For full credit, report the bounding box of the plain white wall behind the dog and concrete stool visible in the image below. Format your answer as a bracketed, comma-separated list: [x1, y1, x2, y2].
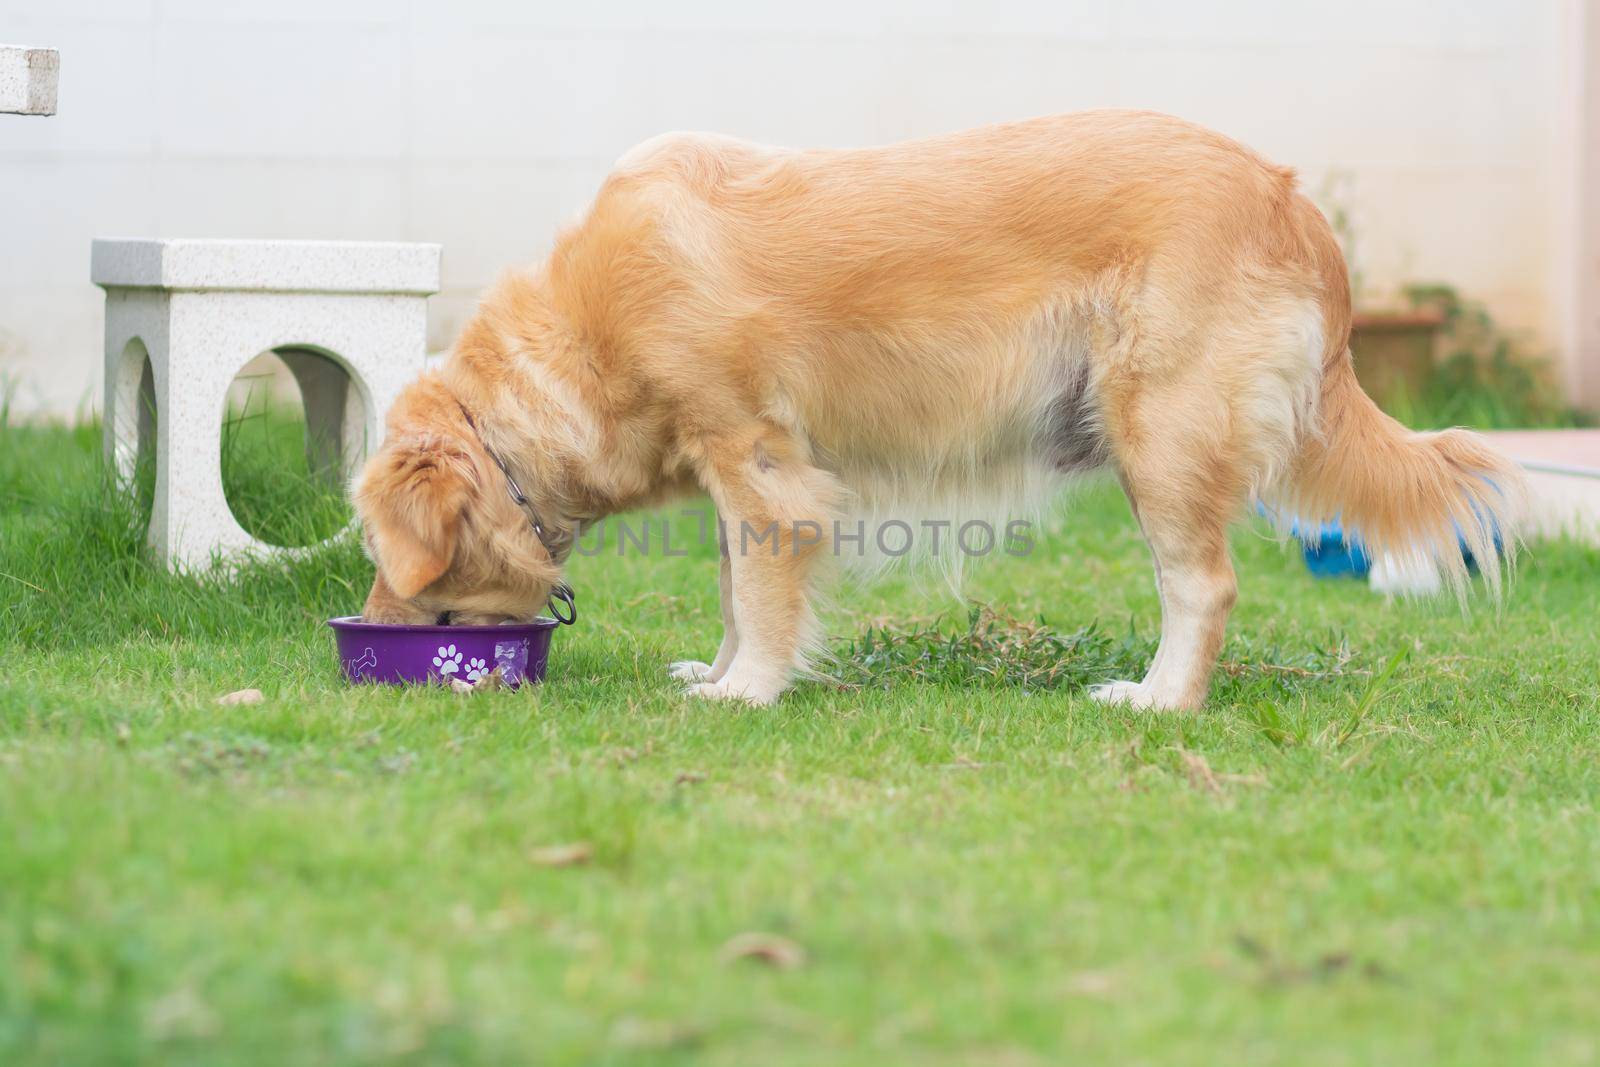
[0, 0, 1571, 411]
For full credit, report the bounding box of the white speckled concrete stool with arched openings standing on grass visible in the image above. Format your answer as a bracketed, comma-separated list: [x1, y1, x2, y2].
[90, 238, 440, 566]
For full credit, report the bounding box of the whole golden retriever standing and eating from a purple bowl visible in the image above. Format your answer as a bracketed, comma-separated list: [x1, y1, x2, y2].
[354, 110, 1518, 709]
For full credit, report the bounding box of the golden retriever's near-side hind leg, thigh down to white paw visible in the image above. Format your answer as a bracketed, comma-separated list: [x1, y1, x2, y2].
[1093, 275, 1325, 709]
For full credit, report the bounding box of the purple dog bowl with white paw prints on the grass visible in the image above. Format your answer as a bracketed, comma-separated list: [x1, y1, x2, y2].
[328, 614, 560, 686]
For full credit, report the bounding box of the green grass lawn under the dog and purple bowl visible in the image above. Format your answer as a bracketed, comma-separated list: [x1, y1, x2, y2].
[0, 426, 1600, 1067]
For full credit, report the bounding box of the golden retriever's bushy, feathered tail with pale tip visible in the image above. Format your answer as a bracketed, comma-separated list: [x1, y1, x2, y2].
[1274, 350, 1525, 598]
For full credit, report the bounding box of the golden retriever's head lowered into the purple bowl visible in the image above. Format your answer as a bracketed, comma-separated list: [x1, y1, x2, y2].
[354, 374, 560, 625]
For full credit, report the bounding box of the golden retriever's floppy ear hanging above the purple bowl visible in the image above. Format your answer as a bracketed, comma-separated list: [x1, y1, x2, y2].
[355, 438, 475, 600]
